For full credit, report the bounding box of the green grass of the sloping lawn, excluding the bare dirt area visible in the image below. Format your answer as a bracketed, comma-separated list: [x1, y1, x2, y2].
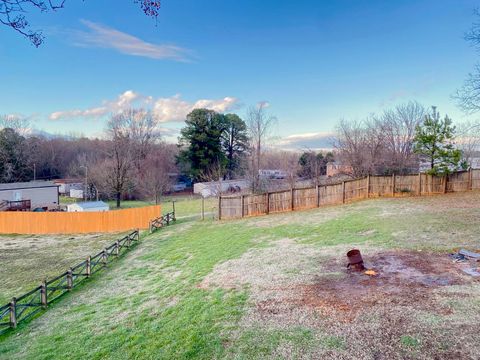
[0, 193, 480, 359]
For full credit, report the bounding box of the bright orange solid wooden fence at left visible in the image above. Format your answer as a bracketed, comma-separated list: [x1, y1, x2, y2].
[0, 205, 161, 234]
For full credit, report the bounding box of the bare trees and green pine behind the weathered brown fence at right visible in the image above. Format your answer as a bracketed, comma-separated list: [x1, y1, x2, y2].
[334, 102, 470, 176]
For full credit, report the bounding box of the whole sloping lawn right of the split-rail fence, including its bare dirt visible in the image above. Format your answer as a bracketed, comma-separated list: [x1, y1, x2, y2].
[0, 192, 480, 359]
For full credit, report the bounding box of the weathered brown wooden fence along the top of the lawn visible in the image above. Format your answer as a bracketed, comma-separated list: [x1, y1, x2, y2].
[218, 170, 480, 219]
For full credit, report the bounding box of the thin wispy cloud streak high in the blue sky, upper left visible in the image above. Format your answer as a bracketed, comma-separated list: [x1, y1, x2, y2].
[74, 20, 192, 62]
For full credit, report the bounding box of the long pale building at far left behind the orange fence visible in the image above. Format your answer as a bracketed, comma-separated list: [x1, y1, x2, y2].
[0, 181, 59, 211]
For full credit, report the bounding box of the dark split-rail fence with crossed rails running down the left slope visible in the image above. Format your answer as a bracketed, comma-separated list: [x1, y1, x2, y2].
[0, 211, 175, 334]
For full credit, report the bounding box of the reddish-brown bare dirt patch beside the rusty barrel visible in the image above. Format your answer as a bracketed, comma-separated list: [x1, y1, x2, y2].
[291, 252, 466, 322]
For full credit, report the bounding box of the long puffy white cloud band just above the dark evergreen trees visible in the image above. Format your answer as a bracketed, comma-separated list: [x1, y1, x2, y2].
[49, 90, 238, 123]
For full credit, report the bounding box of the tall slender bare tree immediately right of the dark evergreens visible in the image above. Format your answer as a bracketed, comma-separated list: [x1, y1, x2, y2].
[247, 102, 276, 192]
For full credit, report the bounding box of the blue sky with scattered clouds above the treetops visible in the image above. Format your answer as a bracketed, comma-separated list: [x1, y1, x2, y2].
[0, 0, 480, 149]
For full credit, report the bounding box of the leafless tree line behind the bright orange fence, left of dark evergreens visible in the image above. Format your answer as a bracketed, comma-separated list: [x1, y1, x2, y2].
[0, 109, 178, 206]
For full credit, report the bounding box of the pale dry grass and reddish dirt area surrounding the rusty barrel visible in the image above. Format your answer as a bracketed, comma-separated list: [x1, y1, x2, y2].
[200, 240, 480, 359]
